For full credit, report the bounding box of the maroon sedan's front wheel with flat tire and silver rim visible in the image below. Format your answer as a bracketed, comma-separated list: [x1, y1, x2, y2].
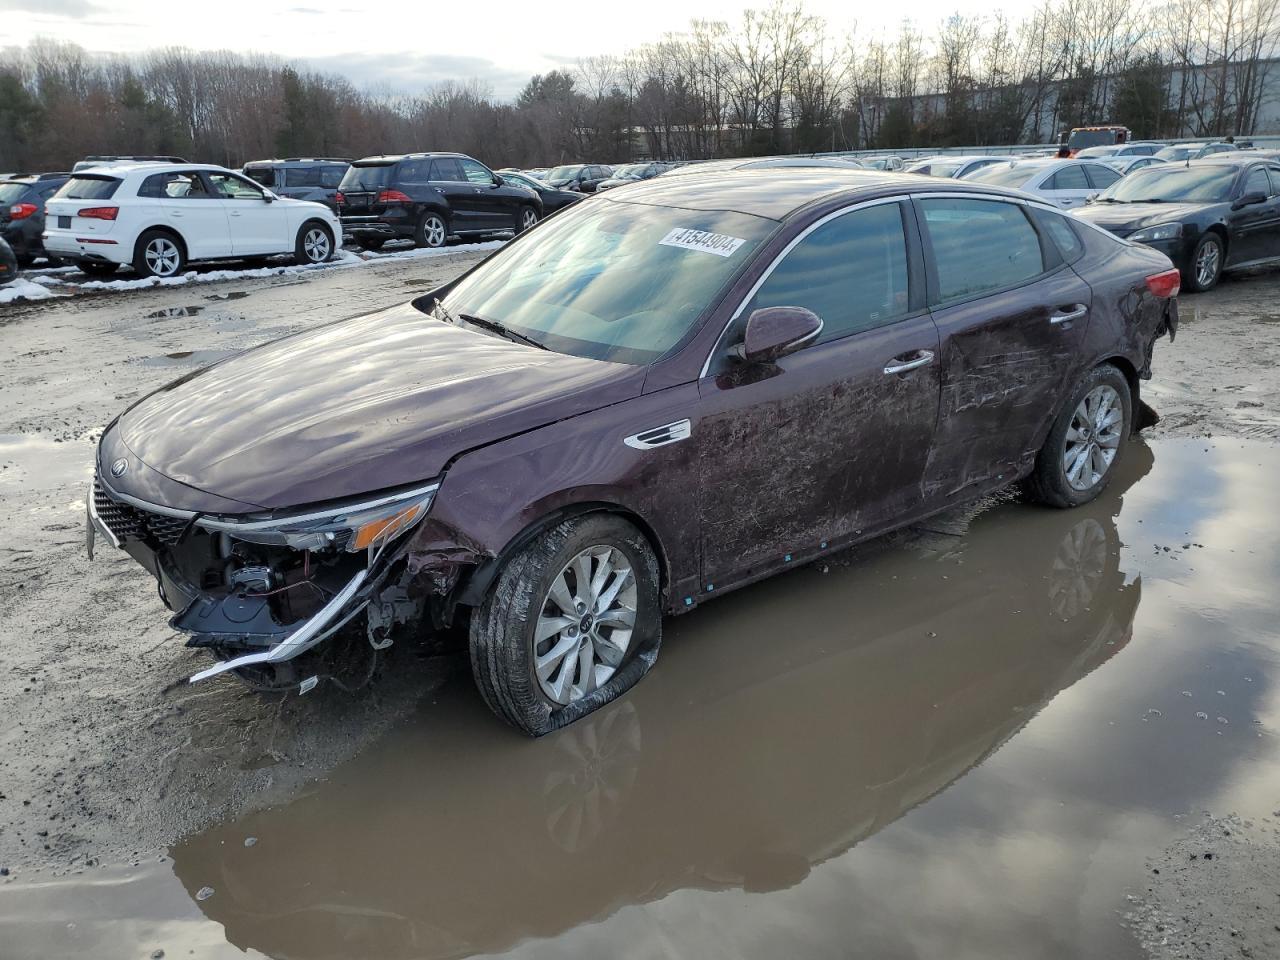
[470, 513, 662, 736]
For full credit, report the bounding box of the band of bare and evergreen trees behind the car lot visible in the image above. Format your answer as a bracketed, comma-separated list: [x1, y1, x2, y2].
[0, 0, 1280, 170]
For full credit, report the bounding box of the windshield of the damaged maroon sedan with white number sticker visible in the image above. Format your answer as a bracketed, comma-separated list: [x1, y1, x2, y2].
[432, 197, 777, 364]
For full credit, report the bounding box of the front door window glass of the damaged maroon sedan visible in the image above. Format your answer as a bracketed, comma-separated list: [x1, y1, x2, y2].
[742, 204, 910, 342]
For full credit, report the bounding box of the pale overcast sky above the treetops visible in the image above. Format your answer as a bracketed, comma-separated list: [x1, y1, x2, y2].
[0, 0, 998, 97]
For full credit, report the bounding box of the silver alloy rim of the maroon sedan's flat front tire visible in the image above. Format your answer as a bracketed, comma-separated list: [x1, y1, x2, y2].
[534, 545, 636, 704]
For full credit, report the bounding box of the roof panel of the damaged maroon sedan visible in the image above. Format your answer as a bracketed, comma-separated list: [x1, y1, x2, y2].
[604, 166, 1027, 220]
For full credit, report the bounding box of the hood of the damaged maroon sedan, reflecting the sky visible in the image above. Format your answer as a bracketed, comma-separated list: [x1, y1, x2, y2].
[118, 303, 644, 509]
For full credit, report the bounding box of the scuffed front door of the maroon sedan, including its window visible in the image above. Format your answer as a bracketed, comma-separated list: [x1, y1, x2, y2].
[696, 201, 940, 589]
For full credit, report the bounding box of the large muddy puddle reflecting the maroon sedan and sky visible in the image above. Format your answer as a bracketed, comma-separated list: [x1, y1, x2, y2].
[0, 442, 1280, 960]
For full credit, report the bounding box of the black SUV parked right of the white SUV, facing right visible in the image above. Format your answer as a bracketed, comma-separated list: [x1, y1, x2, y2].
[337, 154, 543, 250]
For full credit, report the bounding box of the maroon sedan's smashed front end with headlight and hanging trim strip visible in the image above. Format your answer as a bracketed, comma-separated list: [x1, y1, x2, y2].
[86, 476, 438, 690]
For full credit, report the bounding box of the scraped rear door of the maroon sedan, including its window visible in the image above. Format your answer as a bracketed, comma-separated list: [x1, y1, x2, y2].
[915, 196, 1093, 499]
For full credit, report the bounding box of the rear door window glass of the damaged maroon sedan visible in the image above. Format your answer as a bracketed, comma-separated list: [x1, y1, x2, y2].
[919, 197, 1044, 303]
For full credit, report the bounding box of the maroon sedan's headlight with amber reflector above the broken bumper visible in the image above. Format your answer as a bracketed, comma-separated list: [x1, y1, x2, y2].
[196, 484, 440, 553]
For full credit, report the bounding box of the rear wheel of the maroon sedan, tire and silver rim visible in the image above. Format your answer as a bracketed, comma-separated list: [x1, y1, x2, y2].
[1027, 364, 1133, 508]
